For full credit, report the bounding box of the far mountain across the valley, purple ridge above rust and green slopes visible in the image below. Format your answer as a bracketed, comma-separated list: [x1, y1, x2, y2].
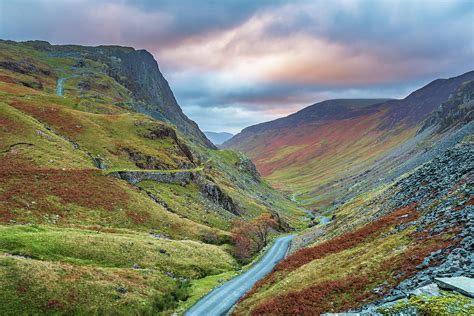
[222, 71, 474, 210]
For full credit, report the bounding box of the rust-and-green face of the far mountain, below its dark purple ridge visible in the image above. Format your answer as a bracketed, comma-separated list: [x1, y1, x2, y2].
[231, 107, 417, 208]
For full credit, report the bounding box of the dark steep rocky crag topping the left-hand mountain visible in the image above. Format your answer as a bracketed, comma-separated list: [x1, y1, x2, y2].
[13, 41, 215, 148]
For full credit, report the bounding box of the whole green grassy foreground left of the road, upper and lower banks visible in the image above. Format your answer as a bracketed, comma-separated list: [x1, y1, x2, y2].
[0, 225, 237, 315]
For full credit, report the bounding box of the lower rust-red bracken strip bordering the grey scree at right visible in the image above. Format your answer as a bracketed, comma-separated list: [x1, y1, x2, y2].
[243, 209, 460, 315]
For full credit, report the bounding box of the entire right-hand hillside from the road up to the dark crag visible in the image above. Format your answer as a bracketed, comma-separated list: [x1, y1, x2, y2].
[234, 81, 474, 315]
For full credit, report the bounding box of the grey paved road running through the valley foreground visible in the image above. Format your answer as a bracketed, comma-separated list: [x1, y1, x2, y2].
[184, 236, 294, 316]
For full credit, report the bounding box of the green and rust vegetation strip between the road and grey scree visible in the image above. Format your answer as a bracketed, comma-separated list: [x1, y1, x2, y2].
[235, 201, 459, 315]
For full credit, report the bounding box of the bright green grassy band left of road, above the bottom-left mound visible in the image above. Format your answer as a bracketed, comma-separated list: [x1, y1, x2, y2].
[0, 225, 236, 278]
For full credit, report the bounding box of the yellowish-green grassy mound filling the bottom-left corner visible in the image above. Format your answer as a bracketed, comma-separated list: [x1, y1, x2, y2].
[0, 254, 176, 315]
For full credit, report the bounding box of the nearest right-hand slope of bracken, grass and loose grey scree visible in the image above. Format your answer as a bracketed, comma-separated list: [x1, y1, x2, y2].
[234, 137, 474, 315]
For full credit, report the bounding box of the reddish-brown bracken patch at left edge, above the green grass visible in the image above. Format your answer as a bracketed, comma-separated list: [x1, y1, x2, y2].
[0, 159, 128, 221]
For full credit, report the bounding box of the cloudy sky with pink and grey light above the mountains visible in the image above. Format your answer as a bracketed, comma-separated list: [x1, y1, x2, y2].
[0, 0, 474, 133]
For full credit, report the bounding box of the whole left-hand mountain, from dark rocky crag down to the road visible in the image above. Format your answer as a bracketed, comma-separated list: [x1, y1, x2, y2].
[0, 41, 304, 315]
